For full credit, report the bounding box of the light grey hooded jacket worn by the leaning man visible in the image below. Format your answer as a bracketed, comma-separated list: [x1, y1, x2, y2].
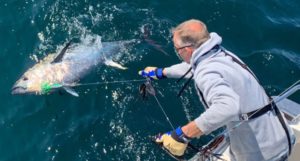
[165, 33, 292, 161]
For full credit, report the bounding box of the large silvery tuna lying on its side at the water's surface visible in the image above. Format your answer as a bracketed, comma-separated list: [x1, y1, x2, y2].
[12, 37, 134, 96]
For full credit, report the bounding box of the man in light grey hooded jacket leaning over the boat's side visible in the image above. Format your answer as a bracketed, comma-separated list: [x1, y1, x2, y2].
[139, 20, 292, 161]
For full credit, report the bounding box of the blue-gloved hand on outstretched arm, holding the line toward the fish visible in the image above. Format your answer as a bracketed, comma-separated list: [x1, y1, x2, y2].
[139, 67, 166, 80]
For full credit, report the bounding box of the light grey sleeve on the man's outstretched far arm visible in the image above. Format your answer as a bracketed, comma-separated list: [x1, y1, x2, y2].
[165, 62, 191, 78]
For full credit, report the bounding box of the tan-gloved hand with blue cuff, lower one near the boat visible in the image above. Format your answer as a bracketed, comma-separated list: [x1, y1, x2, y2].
[155, 127, 190, 156]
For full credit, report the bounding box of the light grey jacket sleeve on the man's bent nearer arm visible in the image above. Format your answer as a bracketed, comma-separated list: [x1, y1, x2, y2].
[195, 65, 240, 134]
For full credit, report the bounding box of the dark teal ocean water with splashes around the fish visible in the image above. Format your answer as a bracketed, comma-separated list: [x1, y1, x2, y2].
[0, 0, 300, 161]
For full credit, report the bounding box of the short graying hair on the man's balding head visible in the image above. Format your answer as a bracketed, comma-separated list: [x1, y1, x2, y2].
[172, 19, 210, 48]
